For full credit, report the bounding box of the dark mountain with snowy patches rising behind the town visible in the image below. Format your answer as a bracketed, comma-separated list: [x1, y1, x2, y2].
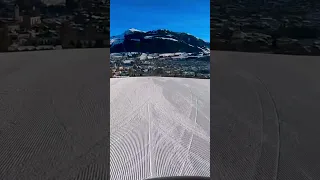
[110, 28, 210, 53]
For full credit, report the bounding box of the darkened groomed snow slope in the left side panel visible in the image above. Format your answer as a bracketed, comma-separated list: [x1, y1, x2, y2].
[0, 49, 110, 180]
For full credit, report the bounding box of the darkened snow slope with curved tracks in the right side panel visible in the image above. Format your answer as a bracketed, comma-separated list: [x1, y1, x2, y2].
[210, 51, 320, 180]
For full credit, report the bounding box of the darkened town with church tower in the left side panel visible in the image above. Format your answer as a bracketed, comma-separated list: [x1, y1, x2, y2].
[0, 0, 110, 52]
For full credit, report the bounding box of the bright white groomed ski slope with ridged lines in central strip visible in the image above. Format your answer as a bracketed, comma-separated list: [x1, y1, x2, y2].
[110, 77, 210, 180]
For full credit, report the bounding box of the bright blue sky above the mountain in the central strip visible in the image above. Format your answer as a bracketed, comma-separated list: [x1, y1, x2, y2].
[110, 0, 210, 41]
